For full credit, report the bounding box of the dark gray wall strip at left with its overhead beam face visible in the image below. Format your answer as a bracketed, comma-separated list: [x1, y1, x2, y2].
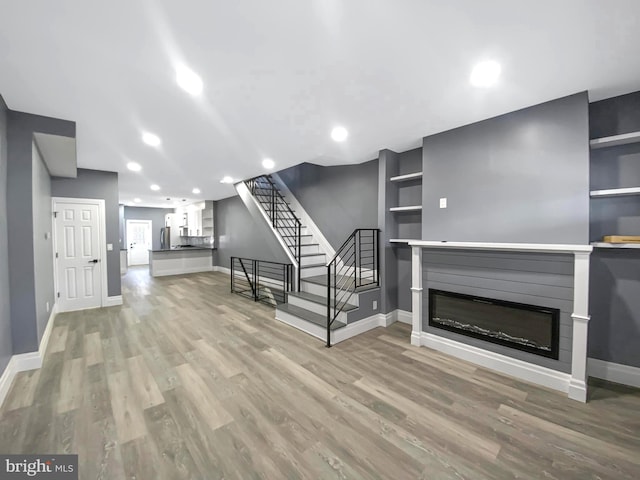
[7, 110, 75, 354]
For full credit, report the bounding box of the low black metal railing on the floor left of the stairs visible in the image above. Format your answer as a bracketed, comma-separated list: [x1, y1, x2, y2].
[231, 257, 293, 306]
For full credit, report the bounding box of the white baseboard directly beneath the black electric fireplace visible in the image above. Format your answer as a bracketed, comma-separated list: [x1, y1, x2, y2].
[420, 332, 571, 393]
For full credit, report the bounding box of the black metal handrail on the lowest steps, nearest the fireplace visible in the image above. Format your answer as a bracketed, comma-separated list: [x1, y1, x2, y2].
[327, 228, 380, 347]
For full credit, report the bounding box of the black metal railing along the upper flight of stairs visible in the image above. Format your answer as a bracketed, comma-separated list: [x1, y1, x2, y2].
[244, 175, 302, 291]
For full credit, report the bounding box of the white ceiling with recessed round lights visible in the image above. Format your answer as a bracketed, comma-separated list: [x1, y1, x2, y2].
[0, 0, 640, 206]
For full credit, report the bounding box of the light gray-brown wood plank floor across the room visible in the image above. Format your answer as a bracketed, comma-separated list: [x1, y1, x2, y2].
[0, 269, 640, 480]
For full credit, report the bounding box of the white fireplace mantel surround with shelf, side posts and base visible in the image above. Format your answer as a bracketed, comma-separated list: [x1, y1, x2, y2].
[400, 239, 593, 402]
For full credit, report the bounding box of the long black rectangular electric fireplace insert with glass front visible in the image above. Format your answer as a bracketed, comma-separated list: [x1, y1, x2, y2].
[429, 288, 560, 359]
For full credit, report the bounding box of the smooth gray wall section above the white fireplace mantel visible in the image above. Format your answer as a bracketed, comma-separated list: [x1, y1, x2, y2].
[422, 92, 589, 244]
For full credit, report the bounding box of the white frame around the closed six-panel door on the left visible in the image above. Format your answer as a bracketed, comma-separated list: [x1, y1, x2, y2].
[51, 197, 109, 312]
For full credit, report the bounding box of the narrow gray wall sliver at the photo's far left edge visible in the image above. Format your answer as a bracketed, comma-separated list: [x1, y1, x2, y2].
[0, 95, 13, 376]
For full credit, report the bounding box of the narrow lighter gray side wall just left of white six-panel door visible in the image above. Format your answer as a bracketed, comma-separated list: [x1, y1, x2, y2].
[31, 142, 55, 345]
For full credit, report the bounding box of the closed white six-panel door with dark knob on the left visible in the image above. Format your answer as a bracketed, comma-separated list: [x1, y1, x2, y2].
[54, 201, 106, 312]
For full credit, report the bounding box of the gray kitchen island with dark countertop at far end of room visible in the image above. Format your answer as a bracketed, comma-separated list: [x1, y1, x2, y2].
[149, 247, 214, 277]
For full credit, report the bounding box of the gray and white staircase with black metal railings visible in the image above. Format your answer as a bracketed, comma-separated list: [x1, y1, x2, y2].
[244, 175, 380, 346]
